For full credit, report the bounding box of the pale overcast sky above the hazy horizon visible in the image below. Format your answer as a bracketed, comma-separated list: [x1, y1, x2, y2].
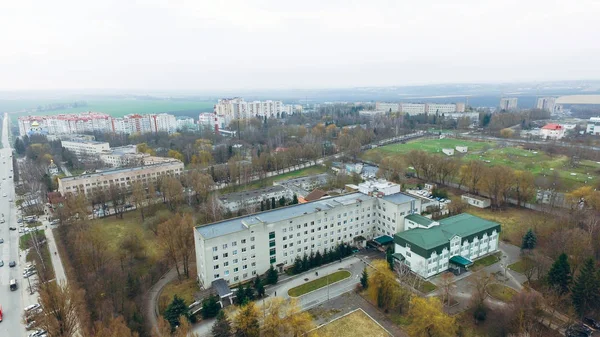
[0, 0, 600, 91]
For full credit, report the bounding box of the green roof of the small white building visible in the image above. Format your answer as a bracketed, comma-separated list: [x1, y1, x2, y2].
[394, 213, 500, 258]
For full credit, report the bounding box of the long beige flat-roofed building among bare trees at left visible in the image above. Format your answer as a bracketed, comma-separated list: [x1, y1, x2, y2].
[58, 160, 183, 196]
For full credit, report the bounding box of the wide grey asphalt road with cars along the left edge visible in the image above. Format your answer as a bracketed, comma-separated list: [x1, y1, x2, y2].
[0, 114, 27, 336]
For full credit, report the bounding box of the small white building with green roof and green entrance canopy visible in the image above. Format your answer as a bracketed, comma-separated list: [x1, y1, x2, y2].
[394, 213, 500, 278]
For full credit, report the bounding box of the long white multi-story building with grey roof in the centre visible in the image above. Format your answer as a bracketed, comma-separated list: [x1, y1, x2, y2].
[194, 193, 420, 287]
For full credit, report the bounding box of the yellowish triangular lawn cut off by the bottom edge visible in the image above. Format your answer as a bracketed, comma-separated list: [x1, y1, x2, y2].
[308, 309, 391, 337]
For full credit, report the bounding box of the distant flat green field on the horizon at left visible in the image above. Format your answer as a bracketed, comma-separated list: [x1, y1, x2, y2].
[0, 98, 214, 118]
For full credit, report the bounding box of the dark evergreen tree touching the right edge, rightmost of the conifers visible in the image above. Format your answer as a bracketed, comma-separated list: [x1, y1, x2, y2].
[571, 259, 600, 317]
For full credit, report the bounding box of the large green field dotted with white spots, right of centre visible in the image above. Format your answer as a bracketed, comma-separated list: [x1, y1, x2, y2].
[363, 138, 600, 191]
